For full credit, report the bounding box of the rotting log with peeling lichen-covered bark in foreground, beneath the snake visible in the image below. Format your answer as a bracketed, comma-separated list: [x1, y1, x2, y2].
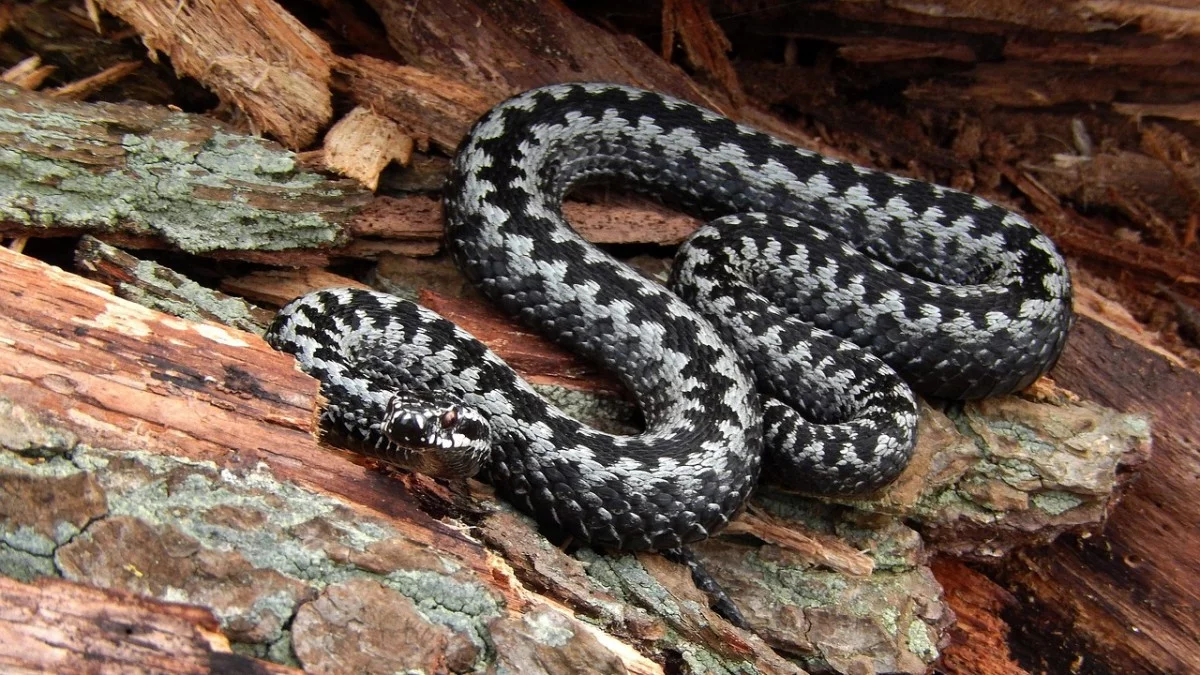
[0, 229, 1139, 673]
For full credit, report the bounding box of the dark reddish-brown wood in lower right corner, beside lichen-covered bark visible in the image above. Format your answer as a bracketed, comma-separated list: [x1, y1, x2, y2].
[1006, 319, 1200, 674]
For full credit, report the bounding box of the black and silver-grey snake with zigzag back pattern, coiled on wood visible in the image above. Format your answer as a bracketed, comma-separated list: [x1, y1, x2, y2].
[266, 83, 1072, 550]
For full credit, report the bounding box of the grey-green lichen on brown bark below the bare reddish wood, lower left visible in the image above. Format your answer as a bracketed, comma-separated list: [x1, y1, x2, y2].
[0, 401, 503, 656]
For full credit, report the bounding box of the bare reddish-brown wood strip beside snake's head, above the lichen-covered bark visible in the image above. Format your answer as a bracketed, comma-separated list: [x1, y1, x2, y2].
[0, 247, 477, 557]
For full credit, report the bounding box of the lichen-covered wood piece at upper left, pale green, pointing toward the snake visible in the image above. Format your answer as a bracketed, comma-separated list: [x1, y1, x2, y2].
[0, 88, 366, 252]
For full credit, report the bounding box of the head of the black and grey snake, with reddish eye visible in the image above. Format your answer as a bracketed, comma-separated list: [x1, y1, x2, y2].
[379, 392, 492, 478]
